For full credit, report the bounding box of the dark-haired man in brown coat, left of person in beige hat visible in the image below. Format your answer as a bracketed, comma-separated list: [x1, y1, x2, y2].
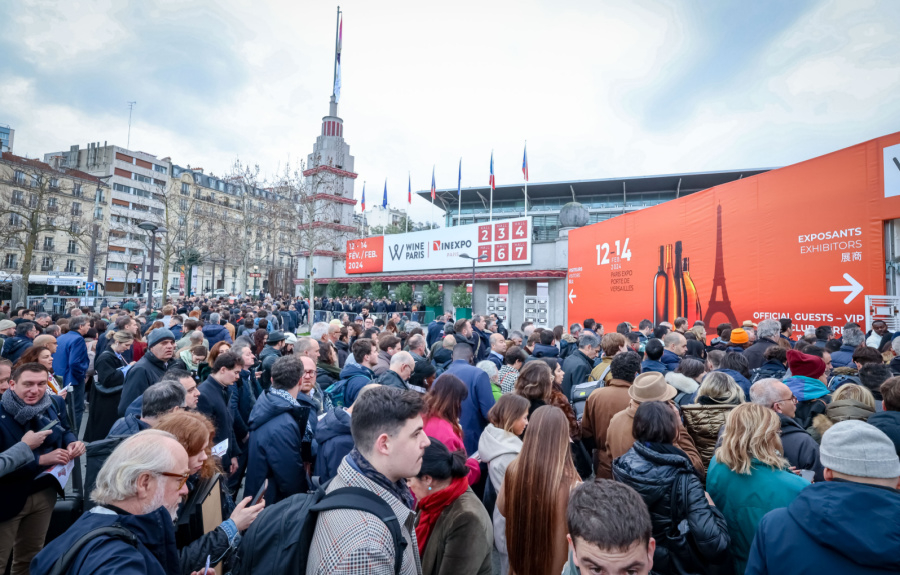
[581, 354, 649, 479]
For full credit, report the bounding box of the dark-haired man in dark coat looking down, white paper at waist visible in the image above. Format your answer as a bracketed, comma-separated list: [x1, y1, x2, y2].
[197, 351, 244, 473]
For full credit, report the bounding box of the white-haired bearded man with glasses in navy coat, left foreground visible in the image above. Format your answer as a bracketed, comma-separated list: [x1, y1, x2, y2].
[31, 429, 212, 575]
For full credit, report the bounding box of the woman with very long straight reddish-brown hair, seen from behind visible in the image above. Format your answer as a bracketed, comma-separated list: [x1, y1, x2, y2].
[497, 404, 581, 575]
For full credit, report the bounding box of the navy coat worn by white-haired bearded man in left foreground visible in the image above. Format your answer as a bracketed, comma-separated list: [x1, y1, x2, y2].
[31, 507, 179, 575]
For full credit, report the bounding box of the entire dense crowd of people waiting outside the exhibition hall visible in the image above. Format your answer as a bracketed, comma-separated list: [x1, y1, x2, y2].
[0, 297, 900, 575]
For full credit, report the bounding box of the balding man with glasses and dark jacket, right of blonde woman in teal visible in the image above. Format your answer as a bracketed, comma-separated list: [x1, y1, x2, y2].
[750, 378, 825, 481]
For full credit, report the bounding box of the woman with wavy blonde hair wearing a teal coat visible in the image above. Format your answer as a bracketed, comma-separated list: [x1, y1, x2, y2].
[706, 403, 809, 574]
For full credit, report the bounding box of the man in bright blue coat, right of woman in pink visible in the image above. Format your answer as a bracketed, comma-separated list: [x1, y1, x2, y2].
[445, 343, 494, 454]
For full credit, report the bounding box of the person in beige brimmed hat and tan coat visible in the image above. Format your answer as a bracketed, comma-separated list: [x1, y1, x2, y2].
[606, 371, 706, 481]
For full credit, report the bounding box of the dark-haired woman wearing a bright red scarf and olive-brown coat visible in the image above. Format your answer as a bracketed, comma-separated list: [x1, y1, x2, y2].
[408, 438, 494, 575]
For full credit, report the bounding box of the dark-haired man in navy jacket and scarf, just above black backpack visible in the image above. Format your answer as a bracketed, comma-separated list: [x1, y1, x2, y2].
[244, 355, 316, 505]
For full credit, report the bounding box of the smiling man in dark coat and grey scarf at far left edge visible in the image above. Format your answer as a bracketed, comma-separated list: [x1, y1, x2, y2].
[0, 363, 84, 573]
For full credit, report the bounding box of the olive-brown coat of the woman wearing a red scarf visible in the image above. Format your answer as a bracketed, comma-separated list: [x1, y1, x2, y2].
[422, 488, 494, 575]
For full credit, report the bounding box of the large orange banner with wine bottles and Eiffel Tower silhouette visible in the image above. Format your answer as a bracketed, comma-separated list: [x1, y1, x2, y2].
[566, 133, 900, 334]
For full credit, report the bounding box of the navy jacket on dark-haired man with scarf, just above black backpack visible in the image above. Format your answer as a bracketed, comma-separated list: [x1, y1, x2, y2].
[246, 392, 315, 505]
